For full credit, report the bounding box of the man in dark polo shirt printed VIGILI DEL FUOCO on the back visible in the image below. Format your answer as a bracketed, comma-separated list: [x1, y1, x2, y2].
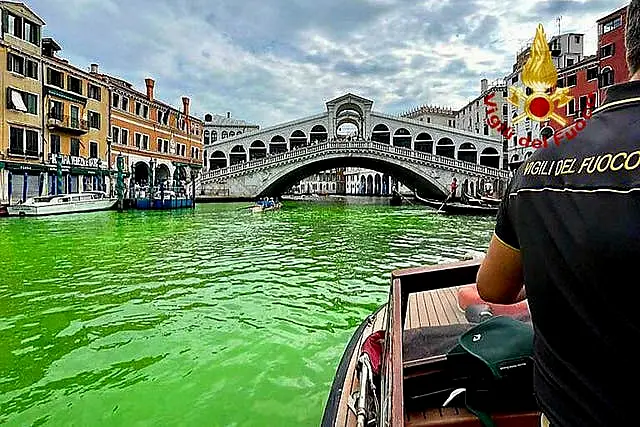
[477, 0, 640, 427]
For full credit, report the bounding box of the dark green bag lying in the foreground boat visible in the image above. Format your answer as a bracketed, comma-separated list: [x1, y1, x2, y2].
[447, 316, 537, 427]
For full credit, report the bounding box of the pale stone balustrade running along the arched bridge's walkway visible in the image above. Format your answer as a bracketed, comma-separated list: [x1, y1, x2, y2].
[200, 140, 509, 181]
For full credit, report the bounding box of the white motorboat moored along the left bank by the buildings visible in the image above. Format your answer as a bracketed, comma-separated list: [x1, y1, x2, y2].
[7, 191, 118, 216]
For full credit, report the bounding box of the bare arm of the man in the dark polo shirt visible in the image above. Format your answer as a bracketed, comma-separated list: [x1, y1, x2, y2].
[476, 234, 526, 304]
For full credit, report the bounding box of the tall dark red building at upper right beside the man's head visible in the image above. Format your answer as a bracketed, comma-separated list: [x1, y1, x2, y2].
[597, 7, 629, 101]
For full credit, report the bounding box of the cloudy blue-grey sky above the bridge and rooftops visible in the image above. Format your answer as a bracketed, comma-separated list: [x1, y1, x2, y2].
[32, 0, 628, 127]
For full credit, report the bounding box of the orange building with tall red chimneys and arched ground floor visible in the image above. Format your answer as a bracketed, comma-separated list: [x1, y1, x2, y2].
[95, 73, 203, 192]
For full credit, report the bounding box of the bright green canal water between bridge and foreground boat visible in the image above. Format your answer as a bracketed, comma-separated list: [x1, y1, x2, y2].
[0, 199, 493, 426]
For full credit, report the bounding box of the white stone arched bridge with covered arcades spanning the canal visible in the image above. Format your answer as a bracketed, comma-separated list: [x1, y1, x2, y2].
[197, 94, 509, 198]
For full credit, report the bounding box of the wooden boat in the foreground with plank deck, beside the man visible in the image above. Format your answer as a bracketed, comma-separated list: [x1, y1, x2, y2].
[321, 259, 540, 427]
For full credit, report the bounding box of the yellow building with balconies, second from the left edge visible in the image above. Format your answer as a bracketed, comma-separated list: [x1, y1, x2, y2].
[42, 37, 111, 194]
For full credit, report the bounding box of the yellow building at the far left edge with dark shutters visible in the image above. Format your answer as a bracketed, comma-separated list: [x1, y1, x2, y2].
[0, 1, 48, 203]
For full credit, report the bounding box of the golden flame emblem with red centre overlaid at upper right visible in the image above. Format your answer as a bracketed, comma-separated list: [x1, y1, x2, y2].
[507, 24, 571, 126]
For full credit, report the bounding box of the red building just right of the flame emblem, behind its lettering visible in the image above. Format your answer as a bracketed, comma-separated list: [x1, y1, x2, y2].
[540, 55, 600, 137]
